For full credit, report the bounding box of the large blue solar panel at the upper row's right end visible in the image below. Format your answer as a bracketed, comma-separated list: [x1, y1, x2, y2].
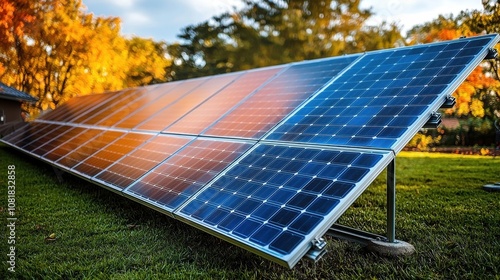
[267, 37, 492, 152]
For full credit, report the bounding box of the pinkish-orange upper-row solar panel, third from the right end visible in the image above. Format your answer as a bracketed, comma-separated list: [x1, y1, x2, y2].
[164, 67, 283, 134]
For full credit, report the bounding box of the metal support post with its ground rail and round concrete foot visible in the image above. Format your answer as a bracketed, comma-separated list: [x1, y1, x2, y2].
[326, 158, 415, 256]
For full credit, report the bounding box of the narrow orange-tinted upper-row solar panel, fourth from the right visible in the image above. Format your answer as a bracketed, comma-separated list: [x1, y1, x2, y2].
[138, 73, 241, 131]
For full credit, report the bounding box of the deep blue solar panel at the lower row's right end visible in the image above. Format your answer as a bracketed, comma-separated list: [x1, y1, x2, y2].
[176, 144, 392, 261]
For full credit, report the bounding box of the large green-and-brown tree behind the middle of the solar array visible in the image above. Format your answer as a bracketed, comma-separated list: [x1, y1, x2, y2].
[170, 0, 401, 79]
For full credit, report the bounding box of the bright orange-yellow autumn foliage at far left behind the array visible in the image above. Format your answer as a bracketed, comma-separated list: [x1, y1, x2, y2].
[0, 0, 169, 116]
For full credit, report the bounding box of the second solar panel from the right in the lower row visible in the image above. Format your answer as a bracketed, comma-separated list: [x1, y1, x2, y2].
[125, 139, 251, 211]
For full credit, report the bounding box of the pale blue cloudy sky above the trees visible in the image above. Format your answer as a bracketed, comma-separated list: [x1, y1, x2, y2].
[83, 0, 482, 43]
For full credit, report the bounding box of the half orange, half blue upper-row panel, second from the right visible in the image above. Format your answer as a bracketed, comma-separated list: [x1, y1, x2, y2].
[202, 55, 358, 139]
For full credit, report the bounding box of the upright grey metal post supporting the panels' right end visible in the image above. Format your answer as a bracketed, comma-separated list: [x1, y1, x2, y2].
[387, 158, 396, 242]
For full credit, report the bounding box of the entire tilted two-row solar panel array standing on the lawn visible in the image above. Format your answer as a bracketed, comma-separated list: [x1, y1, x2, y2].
[2, 35, 499, 267]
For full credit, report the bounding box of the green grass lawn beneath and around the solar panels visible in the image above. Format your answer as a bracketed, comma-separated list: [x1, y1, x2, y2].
[0, 145, 500, 279]
